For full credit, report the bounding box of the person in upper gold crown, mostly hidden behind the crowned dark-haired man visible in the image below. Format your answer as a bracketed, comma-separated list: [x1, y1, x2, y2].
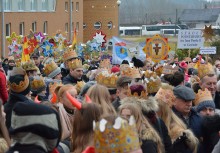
[60, 48, 78, 80]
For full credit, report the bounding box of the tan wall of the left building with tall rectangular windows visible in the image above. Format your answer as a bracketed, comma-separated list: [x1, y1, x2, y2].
[0, 0, 83, 57]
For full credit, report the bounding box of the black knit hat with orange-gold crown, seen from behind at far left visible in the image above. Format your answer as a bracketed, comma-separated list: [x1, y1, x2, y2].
[9, 67, 30, 95]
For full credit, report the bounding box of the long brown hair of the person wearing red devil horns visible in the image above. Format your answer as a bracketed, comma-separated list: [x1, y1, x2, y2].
[72, 103, 102, 153]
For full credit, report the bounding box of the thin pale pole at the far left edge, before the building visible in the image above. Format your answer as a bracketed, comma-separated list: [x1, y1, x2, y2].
[1, 0, 5, 58]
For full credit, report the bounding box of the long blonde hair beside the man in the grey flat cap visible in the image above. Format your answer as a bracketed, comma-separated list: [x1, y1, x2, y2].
[157, 99, 199, 153]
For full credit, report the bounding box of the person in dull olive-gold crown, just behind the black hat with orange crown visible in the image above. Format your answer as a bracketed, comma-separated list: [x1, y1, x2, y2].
[22, 61, 38, 78]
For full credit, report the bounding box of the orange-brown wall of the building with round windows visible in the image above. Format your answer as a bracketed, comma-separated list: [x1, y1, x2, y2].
[83, 0, 118, 42]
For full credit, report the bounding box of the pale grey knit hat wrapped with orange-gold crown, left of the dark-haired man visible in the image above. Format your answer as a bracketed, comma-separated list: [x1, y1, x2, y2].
[43, 58, 61, 78]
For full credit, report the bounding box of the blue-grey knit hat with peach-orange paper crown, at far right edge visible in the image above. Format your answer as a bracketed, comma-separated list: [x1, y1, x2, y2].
[194, 89, 215, 112]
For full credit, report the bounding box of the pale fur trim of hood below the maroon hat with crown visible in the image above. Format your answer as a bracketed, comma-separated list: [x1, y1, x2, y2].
[121, 97, 159, 113]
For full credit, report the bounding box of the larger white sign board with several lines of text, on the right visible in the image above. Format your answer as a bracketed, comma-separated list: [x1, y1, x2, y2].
[177, 30, 204, 49]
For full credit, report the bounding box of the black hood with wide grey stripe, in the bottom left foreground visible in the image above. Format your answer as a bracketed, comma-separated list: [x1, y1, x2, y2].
[9, 102, 61, 152]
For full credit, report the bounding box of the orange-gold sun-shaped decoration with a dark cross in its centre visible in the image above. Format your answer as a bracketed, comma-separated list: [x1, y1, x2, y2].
[143, 35, 170, 63]
